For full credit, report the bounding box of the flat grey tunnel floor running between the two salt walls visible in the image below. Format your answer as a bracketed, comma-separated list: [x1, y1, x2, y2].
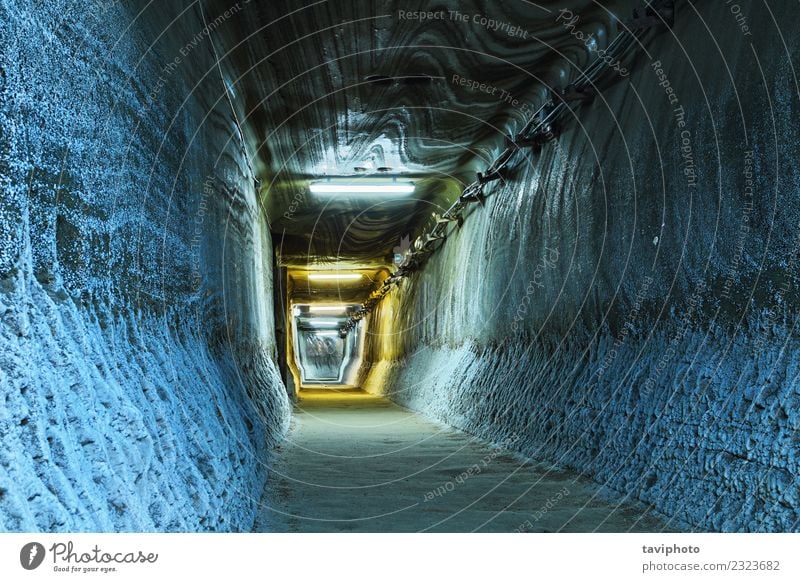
[255, 390, 668, 532]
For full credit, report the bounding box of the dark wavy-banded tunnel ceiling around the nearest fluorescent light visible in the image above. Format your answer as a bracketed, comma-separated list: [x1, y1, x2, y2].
[207, 0, 620, 266]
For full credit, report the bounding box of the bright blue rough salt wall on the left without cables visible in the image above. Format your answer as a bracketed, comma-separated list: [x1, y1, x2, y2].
[0, 0, 288, 531]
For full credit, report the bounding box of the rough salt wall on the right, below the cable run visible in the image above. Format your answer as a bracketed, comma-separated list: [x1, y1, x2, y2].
[366, 2, 800, 531]
